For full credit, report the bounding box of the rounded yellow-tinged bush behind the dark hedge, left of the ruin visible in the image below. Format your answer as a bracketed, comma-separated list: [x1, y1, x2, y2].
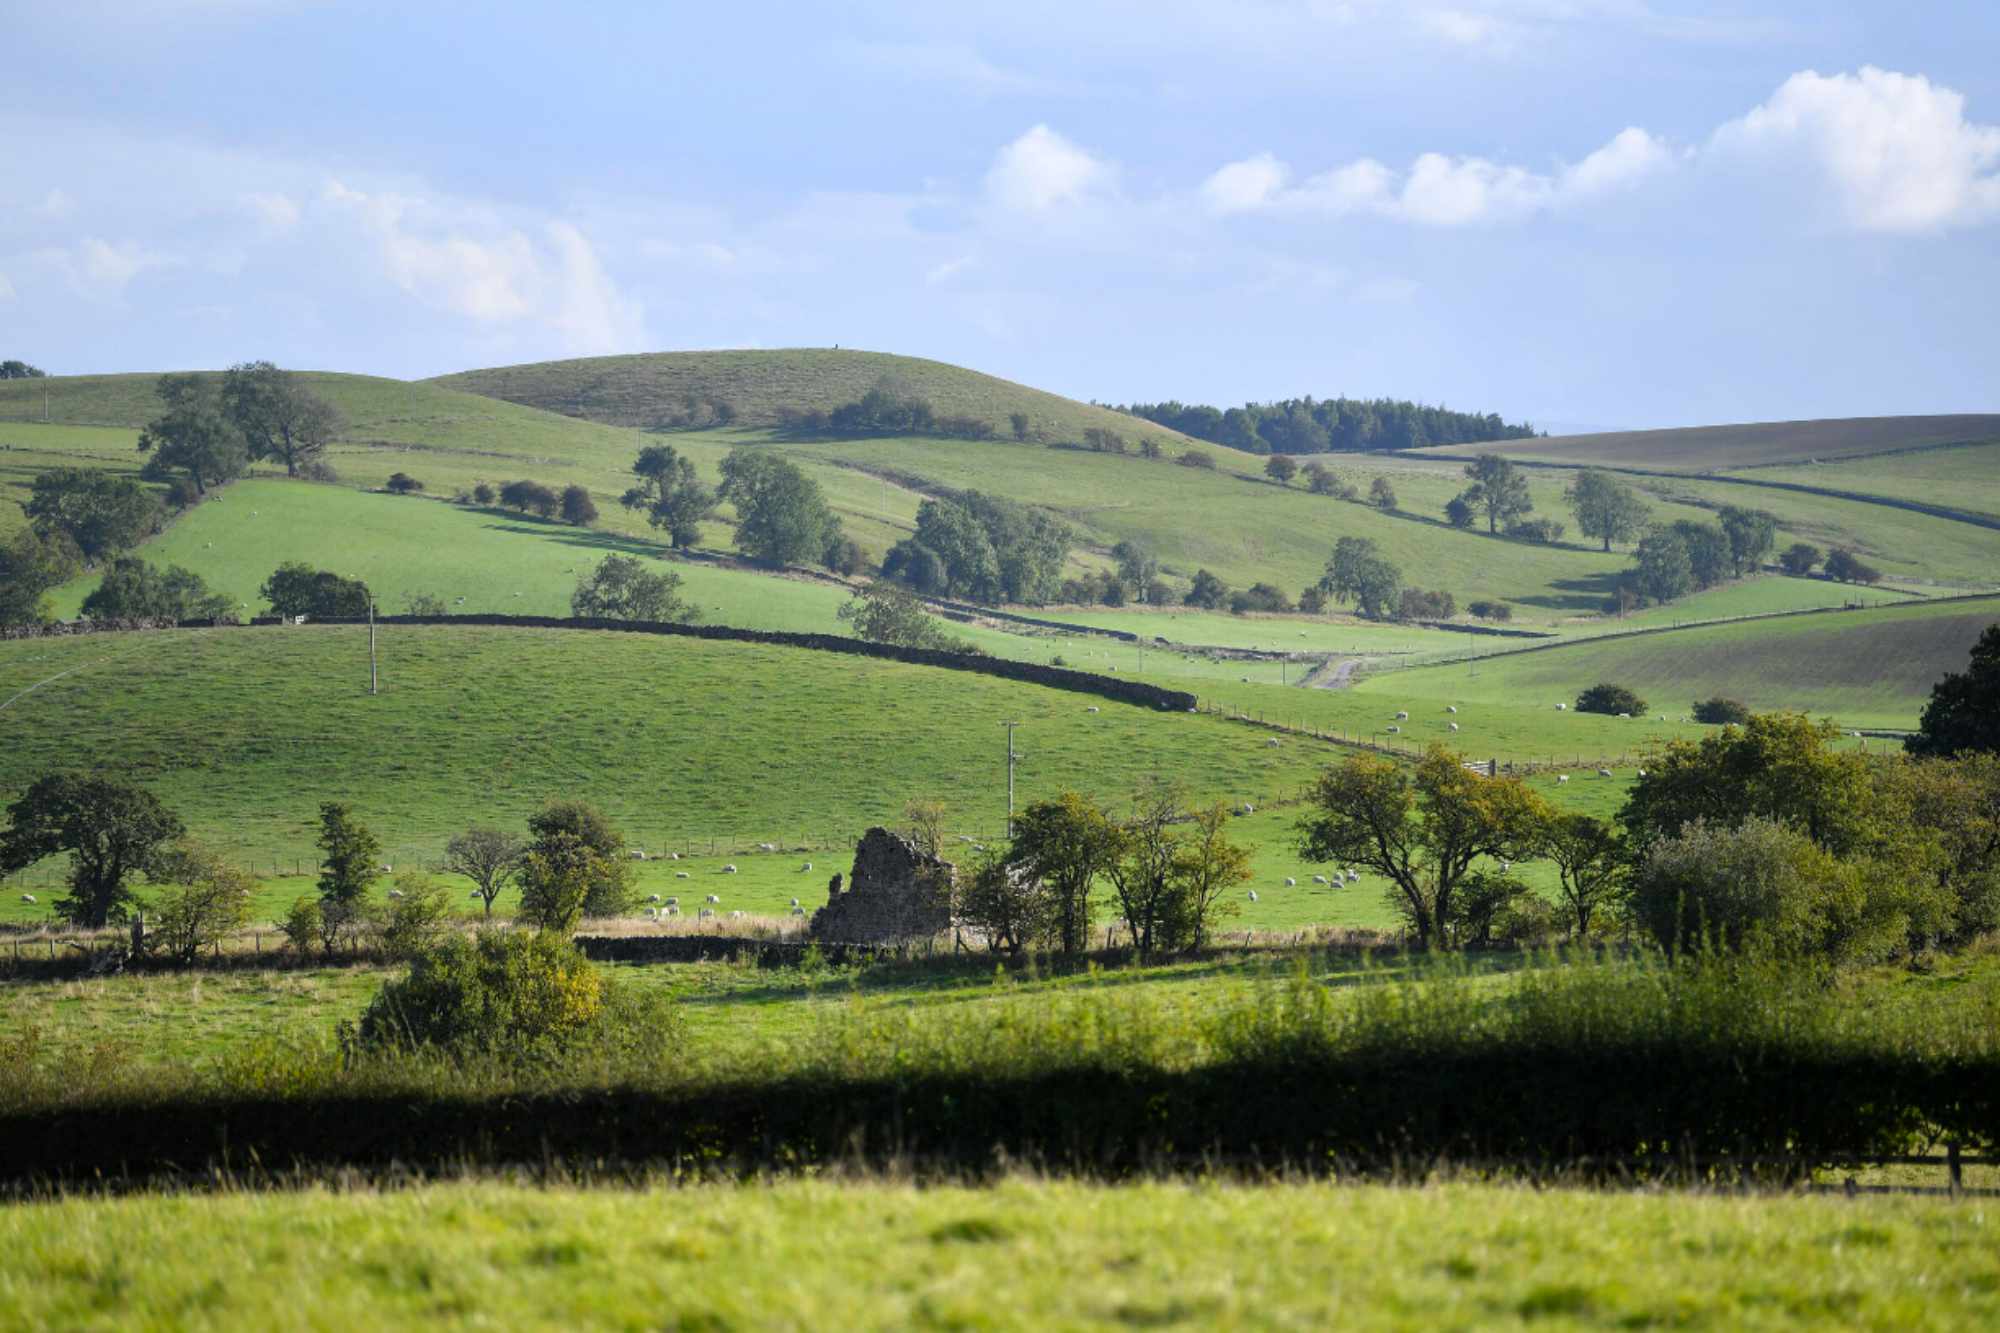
[354, 931, 604, 1061]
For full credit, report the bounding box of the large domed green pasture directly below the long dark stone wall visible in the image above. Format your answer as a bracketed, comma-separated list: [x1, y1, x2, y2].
[0, 624, 1324, 885]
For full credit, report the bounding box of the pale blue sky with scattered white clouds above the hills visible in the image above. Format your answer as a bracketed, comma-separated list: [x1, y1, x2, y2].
[0, 0, 2000, 428]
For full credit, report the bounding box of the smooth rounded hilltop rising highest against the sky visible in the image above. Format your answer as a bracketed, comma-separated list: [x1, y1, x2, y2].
[430, 346, 1186, 442]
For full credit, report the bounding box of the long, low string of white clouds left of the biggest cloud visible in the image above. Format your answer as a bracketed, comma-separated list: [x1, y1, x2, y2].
[1202, 130, 1674, 226]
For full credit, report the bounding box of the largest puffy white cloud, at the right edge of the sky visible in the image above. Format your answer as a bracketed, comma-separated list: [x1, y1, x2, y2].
[1712, 66, 2000, 232]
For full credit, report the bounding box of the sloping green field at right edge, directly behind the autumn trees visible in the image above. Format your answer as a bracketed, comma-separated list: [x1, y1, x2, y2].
[1354, 598, 2000, 732]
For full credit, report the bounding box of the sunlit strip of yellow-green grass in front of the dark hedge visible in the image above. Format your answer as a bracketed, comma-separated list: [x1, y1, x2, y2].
[0, 1179, 2000, 1329]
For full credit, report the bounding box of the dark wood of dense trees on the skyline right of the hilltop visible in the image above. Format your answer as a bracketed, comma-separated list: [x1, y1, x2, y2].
[1118, 396, 1536, 454]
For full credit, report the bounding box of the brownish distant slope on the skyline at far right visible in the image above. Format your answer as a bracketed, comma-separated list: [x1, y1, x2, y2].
[1420, 414, 2000, 472]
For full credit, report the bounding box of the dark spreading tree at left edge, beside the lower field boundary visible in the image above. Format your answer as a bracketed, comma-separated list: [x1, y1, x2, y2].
[0, 773, 186, 927]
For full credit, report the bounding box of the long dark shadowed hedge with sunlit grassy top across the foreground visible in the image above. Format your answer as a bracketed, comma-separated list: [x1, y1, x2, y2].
[0, 957, 2000, 1179]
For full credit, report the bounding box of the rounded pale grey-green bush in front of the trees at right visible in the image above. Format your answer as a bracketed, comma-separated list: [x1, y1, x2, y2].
[1632, 817, 1908, 963]
